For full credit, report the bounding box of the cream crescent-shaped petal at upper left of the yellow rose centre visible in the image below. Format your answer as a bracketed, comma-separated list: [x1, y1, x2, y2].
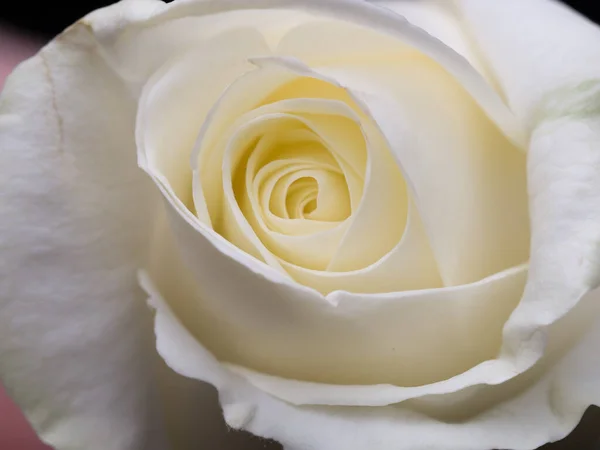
[136, 29, 269, 226]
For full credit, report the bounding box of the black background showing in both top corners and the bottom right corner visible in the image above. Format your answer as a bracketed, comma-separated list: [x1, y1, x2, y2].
[0, 0, 600, 450]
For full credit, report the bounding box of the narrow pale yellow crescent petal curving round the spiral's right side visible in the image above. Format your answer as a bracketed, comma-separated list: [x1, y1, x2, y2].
[248, 58, 408, 272]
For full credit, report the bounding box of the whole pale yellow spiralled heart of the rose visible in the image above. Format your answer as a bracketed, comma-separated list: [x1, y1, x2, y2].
[190, 58, 420, 293]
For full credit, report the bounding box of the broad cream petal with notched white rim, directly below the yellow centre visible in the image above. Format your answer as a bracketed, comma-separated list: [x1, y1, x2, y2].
[151, 194, 525, 394]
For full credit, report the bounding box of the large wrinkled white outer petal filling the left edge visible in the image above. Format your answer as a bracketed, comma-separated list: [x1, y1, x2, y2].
[0, 1, 166, 450]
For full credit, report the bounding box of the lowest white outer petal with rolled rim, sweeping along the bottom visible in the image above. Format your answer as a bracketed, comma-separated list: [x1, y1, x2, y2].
[141, 248, 600, 450]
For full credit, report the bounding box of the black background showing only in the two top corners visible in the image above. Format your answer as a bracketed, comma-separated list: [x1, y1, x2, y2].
[0, 0, 600, 37]
